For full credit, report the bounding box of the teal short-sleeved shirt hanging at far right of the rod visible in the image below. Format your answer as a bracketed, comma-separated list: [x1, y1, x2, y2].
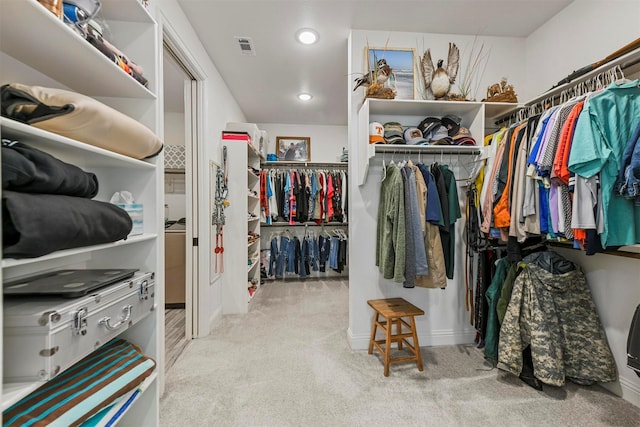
[569, 80, 640, 247]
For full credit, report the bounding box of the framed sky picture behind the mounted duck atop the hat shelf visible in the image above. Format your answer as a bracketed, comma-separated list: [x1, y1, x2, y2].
[365, 48, 417, 99]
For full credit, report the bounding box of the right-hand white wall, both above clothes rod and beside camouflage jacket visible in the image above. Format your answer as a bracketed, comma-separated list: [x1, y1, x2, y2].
[526, 0, 640, 406]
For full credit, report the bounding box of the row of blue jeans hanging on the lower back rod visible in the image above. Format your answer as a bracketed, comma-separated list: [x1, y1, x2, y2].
[264, 229, 348, 278]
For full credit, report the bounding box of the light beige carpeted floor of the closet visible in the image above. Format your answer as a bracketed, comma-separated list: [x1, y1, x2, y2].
[160, 280, 640, 427]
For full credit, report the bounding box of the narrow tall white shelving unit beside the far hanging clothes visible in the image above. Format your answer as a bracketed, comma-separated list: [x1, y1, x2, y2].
[222, 141, 263, 314]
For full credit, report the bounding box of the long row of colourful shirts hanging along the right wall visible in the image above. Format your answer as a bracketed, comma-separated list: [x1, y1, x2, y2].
[480, 72, 640, 254]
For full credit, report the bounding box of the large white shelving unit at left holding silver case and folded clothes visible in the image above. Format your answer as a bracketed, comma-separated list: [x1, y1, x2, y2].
[0, 0, 164, 426]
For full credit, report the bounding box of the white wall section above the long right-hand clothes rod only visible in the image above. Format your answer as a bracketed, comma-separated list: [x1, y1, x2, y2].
[521, 0, 640, 101]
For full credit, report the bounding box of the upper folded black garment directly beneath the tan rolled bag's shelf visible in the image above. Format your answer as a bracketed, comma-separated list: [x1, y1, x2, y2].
[2, 139, 98, 199]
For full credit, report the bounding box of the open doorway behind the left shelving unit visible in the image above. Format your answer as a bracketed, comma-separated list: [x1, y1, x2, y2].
[162, 38, 198, 372]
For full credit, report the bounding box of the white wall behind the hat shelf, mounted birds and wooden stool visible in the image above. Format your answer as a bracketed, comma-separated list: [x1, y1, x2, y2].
[346, 30, 525, 349]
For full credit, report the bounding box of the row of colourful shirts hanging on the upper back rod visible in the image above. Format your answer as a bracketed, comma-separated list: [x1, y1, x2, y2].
[260, 169, 347, 225]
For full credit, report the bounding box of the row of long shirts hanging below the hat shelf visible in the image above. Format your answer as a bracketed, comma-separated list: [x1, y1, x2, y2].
[376, 161, 461, 288]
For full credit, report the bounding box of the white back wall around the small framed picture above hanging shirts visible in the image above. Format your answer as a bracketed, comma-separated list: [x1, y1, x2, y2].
[258, 124, 348, 162]
